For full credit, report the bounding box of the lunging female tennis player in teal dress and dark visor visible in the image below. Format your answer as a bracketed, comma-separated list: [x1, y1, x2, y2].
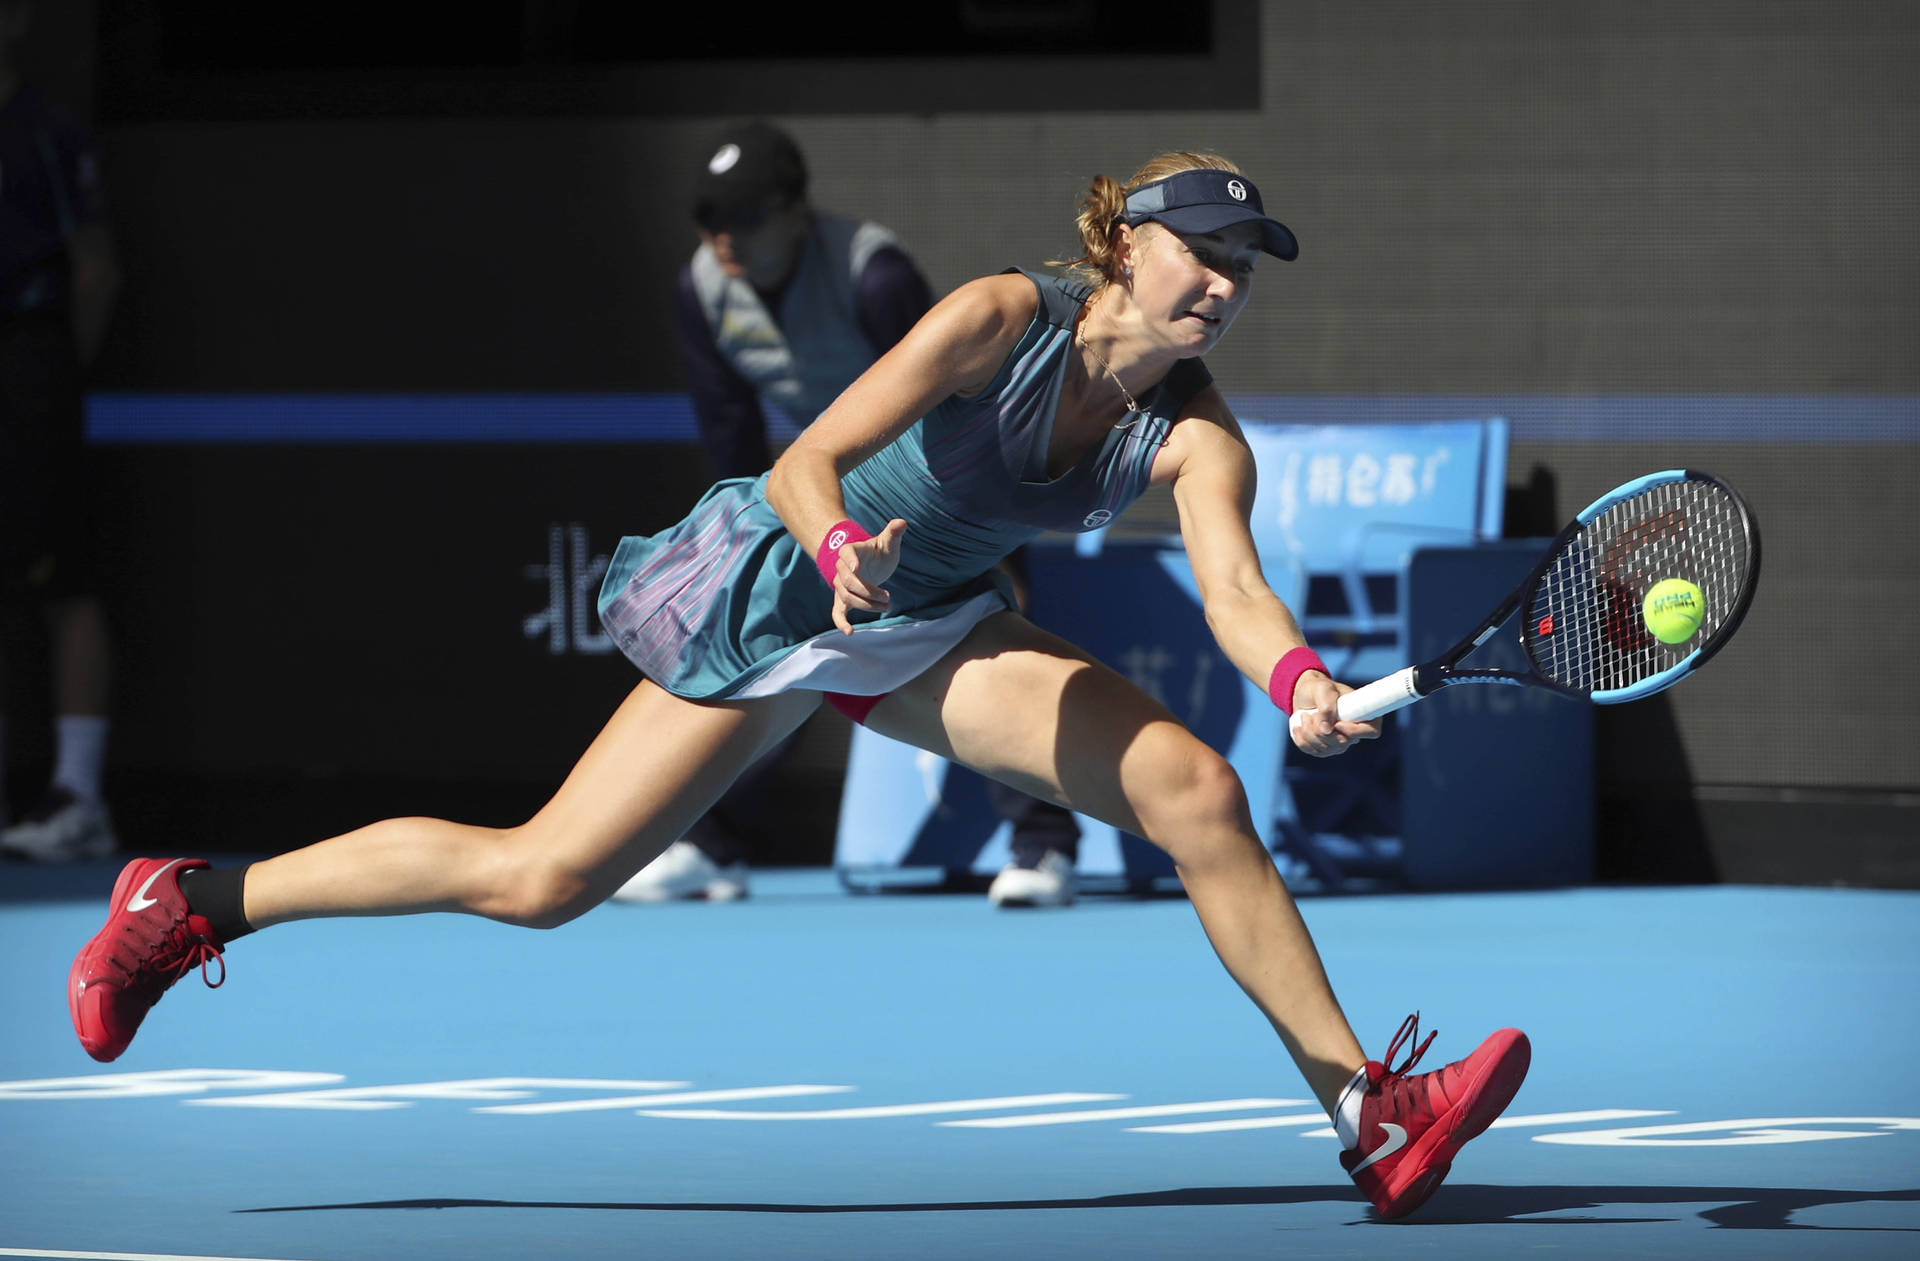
[69, 154, 1528, 1217]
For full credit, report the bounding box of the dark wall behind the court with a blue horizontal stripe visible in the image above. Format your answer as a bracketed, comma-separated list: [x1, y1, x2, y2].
[7, 0, 1920, 881]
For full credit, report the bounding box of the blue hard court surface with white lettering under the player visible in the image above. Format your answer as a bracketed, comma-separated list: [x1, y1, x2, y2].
[0, 866, 1920, 1261]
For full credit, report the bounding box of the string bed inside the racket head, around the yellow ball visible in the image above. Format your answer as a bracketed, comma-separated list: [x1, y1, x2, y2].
[1523, 480, 1749, 693]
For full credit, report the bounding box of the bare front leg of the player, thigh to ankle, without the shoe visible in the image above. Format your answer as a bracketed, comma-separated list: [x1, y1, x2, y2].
[868, 614, 1367, 1111]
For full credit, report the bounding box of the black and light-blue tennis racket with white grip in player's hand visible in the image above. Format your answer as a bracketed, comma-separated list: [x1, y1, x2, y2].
[1296, 468, 1761, 722]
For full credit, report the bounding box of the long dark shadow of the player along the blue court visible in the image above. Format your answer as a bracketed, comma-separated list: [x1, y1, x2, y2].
[238, 1184, 1920, 1234]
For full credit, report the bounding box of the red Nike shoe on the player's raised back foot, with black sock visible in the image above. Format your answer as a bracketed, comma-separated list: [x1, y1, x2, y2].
[67, 858, 227, 1063]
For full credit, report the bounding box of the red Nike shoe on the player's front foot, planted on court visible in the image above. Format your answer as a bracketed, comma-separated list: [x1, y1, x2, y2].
[1340, 1011, 1532, 1217]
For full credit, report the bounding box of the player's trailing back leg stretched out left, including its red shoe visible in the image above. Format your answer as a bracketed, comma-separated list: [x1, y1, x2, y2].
[67, 683, 820, 1061]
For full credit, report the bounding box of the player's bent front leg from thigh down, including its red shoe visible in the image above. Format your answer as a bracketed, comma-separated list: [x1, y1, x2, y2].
[868, 614, 1530, 1217]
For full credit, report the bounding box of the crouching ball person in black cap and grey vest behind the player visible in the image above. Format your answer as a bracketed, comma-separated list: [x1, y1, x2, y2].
[614, 119, 1079, 906]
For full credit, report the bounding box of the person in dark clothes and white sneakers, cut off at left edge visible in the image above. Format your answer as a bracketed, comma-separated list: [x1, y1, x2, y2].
[0, 0, 119, 862]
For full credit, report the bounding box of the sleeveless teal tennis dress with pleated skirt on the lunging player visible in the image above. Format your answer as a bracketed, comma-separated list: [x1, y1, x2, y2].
[599, 273, 1212, 701]
